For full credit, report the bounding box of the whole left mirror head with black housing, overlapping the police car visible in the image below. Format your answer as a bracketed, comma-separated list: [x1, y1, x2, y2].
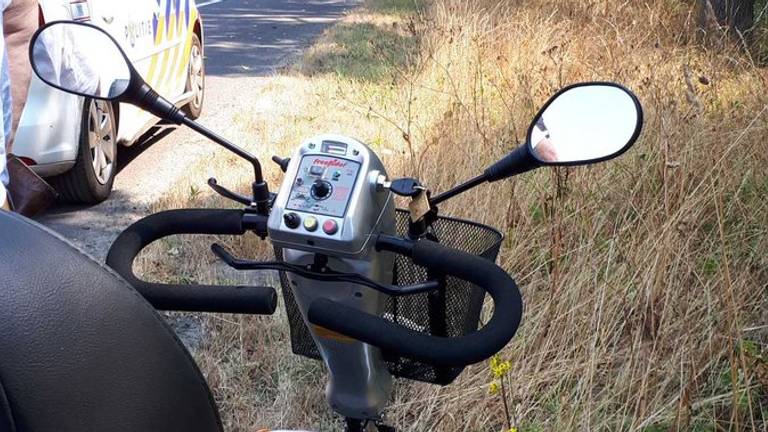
[29, 21, 188, 124]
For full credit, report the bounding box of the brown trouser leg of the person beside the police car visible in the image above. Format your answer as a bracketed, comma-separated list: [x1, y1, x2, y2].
[3, 0, 39, 153]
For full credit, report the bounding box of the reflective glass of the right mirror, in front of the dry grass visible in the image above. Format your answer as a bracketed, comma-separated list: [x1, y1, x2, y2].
[528, 84, 642, 165]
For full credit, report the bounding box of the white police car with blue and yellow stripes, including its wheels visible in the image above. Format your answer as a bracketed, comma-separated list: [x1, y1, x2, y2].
[13, 0, 205, 203]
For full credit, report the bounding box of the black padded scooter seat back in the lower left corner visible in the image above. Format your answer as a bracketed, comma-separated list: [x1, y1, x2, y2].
[0, 211, 222, 432]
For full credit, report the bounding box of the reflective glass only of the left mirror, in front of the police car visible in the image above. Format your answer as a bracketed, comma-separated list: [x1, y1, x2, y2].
[30, 21, 131, 100]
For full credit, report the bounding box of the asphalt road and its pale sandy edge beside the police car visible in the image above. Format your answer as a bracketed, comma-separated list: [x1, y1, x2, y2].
[40, 0, 359, 261]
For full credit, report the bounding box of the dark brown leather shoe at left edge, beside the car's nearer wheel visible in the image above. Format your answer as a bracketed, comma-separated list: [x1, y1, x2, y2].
[8, 155, 58, 217]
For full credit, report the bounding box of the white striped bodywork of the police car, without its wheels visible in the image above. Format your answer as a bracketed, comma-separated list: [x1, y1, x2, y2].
[13, 0, 203, 177]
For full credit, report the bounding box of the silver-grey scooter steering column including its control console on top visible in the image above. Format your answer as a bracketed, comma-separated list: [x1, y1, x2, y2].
[268, 135, 395, 419]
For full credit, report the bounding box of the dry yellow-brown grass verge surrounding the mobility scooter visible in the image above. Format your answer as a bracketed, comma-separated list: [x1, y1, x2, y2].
[136, 0, 768, 431]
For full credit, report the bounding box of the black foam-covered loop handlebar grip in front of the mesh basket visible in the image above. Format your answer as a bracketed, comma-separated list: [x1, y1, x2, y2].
[308, 240, 523, 366]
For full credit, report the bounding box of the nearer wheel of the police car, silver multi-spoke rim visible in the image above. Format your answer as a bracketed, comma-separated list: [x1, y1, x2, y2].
[51, 99, 117, 204]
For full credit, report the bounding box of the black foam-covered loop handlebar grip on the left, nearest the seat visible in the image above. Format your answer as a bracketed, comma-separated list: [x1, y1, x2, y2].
[107, 209, 277, 315]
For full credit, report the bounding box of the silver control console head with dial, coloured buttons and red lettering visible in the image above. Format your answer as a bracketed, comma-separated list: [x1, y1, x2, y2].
[268, 135, 394, 256]
